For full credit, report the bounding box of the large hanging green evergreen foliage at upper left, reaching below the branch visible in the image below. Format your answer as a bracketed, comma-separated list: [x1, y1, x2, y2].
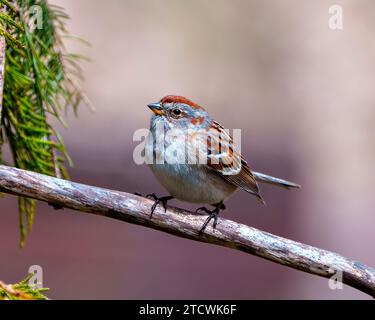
[0, 0, 85, 246]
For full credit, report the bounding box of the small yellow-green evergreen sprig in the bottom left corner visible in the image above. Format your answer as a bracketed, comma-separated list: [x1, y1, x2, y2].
[0, 274, 48, 300]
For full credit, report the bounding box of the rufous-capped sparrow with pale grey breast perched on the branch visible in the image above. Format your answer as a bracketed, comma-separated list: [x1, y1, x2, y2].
[145, 95, 300, 233]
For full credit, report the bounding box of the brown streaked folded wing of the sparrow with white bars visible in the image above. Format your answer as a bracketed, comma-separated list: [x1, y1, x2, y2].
[188, 121, 264, 203]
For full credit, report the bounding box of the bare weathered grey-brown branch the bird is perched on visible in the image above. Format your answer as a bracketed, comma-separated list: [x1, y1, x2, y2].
[0, 166, 375, 297]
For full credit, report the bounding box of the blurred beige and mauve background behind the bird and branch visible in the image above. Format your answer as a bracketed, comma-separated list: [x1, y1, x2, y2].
[0, 0, 375, 299]
